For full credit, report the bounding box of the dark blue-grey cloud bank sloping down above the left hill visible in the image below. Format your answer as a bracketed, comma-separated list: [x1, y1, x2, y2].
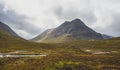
[0, 4, 41, 37]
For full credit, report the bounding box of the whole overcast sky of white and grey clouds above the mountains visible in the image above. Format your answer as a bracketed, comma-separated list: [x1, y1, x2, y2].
[0, 0, 120, 39]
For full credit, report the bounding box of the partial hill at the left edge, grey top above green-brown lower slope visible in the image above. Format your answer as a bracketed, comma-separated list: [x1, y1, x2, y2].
[0, 22, 25, 43]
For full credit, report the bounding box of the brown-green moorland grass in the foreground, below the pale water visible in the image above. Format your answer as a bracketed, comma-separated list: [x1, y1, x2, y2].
[0, 53, 120, 70]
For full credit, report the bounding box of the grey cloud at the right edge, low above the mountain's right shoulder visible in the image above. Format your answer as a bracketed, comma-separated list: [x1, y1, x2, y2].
[95, 12, 120, 37]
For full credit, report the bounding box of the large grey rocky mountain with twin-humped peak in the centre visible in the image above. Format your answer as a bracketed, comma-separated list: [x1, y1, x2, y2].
[32, 19, 103, 42]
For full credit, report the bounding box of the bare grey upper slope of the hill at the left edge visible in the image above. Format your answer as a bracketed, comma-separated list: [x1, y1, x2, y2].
[0, 22, 19, 37]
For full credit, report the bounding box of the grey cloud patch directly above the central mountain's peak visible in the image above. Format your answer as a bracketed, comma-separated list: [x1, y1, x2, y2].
[54, 6, 97, 25]
